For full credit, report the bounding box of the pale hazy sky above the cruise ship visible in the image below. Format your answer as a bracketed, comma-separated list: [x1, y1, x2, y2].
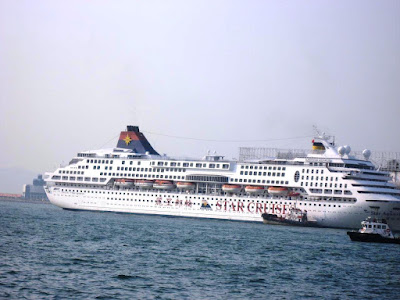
[0, 0, 400, 172]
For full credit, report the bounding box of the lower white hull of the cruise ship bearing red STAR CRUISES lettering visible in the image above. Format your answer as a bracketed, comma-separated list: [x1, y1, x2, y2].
[46, 188, 400, 231]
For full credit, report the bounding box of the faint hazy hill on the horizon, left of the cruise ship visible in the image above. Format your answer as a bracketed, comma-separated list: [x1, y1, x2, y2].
[0, 168, 38, 194]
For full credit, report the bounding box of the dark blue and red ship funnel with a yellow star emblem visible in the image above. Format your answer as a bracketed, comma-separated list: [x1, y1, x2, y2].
[117, 125, 159, 155]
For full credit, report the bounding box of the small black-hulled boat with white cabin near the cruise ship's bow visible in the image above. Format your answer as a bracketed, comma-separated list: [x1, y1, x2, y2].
[347, 217, 400, 244]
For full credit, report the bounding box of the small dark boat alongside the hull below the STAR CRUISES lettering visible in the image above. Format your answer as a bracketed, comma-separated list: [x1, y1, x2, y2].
[261, 207, 318, 227]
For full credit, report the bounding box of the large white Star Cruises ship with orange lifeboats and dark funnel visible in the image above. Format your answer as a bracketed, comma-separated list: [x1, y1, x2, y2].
[45, 126, 400, 231]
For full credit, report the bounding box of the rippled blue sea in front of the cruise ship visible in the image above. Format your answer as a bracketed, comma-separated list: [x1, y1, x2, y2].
[0, 202, 400, 299]
